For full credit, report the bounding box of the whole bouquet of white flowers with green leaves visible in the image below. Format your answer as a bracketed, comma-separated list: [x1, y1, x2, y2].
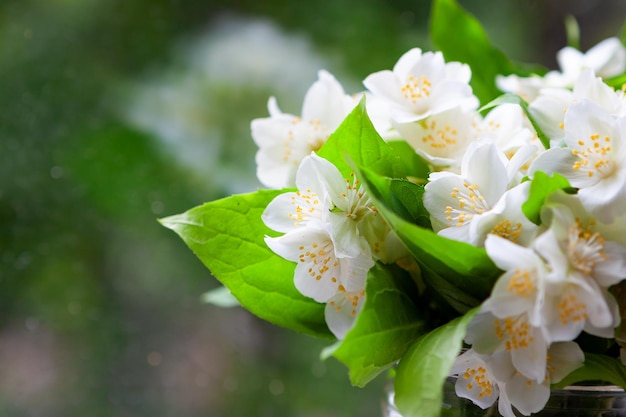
[161, 0, 626, 417]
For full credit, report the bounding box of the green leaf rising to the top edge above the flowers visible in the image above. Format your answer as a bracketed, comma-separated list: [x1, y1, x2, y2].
[430, 0, 521, 103]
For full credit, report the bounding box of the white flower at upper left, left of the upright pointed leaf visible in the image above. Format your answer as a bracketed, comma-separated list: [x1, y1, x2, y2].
[251, 71, 356, 189]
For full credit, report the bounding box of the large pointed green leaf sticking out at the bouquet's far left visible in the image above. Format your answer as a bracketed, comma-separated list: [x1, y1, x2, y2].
[160, 190, 331, 337]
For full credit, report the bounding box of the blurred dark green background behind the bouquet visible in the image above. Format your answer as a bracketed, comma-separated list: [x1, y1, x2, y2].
[0, 0, 626, 417]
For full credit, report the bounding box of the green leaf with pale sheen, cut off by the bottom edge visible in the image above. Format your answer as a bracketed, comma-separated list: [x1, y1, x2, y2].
[394, 309, 478, 417]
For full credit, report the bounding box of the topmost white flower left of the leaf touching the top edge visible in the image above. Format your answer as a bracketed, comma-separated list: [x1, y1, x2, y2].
[363, 48, 478, 123]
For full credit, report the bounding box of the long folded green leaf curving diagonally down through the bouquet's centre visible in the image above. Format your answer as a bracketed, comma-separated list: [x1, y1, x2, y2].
[360, 168, 500, 313]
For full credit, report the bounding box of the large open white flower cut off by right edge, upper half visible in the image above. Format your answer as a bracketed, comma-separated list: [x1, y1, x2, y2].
[530, 100, 626, 223]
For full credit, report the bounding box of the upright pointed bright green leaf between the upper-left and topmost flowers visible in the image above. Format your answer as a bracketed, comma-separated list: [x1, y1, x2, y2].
[318, 97, 406, 178]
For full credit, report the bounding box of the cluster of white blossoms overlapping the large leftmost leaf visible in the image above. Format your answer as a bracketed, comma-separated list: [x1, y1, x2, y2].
[262, 153, 394, 339]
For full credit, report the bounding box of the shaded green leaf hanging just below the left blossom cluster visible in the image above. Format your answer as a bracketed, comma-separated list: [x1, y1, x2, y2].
[327, 264, 426, 386]
